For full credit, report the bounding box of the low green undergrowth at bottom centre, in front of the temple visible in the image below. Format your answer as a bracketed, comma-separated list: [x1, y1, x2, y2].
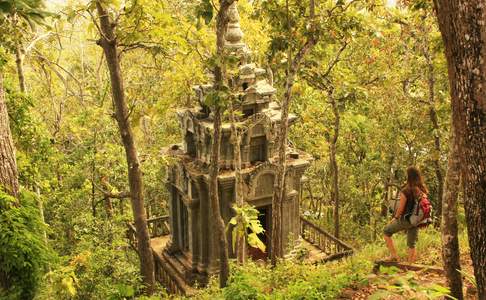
[192, 257, 372, 300]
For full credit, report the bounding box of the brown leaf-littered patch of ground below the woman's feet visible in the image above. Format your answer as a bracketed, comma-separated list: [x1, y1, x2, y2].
[339, 253, 476, 300]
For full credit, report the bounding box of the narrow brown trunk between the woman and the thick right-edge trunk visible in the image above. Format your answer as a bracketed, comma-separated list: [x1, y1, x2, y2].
[442, 129, 463, 300]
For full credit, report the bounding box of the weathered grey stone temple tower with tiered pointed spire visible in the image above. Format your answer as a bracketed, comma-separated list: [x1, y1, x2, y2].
[164, 4, 311, 283]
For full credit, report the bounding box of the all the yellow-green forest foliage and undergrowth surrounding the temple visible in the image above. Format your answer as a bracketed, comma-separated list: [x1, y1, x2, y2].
[0, 0, 468, 299]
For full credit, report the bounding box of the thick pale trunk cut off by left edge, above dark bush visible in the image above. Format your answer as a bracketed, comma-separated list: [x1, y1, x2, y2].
[0, 66, 19, 198]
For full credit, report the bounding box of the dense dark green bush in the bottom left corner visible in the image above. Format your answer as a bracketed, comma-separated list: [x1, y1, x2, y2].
[0, 192, 53, 299]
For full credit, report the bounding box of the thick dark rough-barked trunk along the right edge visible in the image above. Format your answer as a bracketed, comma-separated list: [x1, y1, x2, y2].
[434, 0, 486, 300]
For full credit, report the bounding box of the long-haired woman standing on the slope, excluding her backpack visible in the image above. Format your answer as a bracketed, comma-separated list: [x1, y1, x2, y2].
[383, 167, 429, 263]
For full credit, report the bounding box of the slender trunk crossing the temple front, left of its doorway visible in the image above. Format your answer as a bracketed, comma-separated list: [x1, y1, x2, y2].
[209, 0, 236, 288]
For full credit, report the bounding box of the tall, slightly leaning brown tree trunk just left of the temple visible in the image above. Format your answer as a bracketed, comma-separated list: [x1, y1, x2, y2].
[96, 1, 155, 295]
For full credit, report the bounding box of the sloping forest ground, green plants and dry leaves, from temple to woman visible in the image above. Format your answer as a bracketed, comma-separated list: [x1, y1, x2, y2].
[195, 226, 476, 300]
